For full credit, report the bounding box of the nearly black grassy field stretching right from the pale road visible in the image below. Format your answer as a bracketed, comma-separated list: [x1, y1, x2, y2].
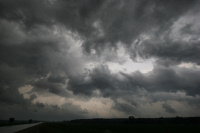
[20, 123, 200, 133]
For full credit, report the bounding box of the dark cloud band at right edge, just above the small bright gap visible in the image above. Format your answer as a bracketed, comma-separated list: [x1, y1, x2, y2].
[133, 36, 200, 64]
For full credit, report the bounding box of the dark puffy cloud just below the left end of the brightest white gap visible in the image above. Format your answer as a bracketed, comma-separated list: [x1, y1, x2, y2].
[69, 65, 116, 95]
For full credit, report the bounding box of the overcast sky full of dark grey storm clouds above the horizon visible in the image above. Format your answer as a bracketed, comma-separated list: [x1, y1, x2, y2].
[0, 0, 200, 120]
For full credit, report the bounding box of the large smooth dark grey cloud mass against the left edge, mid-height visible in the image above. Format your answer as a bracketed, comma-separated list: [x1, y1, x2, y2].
[0, 20, 67, 101]
